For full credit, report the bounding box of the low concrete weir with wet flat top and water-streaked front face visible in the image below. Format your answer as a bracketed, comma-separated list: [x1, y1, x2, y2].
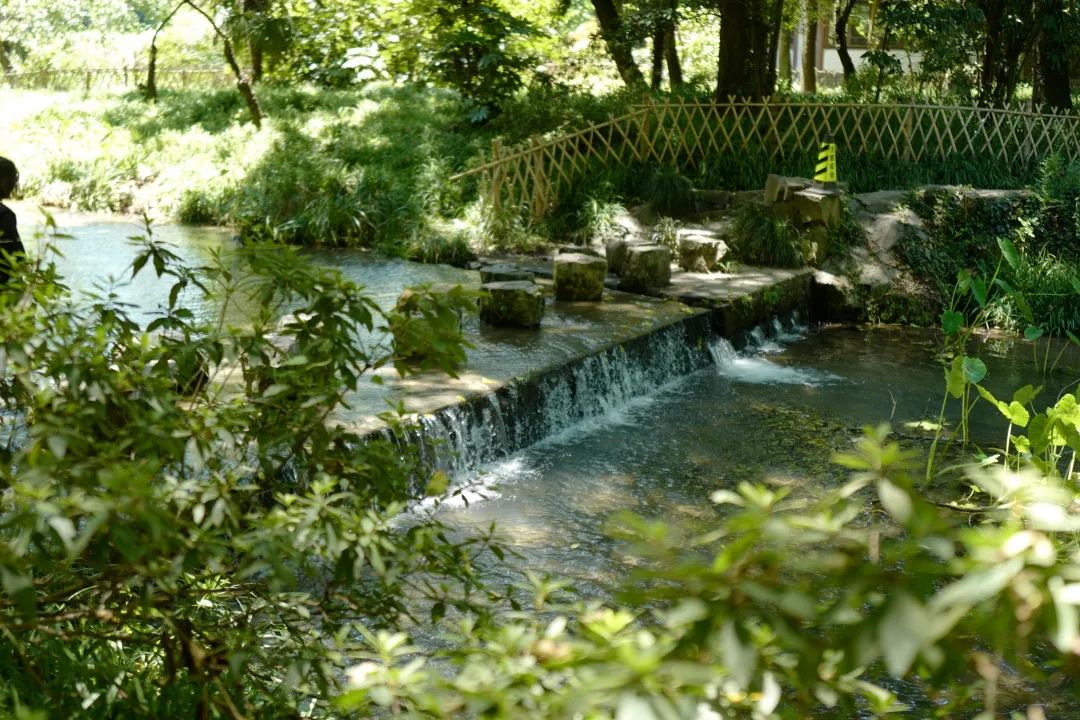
[354, 264, 812, 477]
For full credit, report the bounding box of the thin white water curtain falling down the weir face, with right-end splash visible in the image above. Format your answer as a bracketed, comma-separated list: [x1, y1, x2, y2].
[395, 314, 836, 490]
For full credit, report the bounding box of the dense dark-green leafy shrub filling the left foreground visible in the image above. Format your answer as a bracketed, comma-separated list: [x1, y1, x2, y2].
[0, 222, 496, 718]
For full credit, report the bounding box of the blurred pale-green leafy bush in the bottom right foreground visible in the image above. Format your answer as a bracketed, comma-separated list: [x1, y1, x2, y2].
[339, 423, 1080, 719]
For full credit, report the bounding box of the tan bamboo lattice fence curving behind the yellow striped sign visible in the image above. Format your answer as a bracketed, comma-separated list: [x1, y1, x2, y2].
[450, 100, 1080, 219]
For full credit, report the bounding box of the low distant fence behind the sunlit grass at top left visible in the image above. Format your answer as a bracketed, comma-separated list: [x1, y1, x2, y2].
[0, 67, 235, 94]
